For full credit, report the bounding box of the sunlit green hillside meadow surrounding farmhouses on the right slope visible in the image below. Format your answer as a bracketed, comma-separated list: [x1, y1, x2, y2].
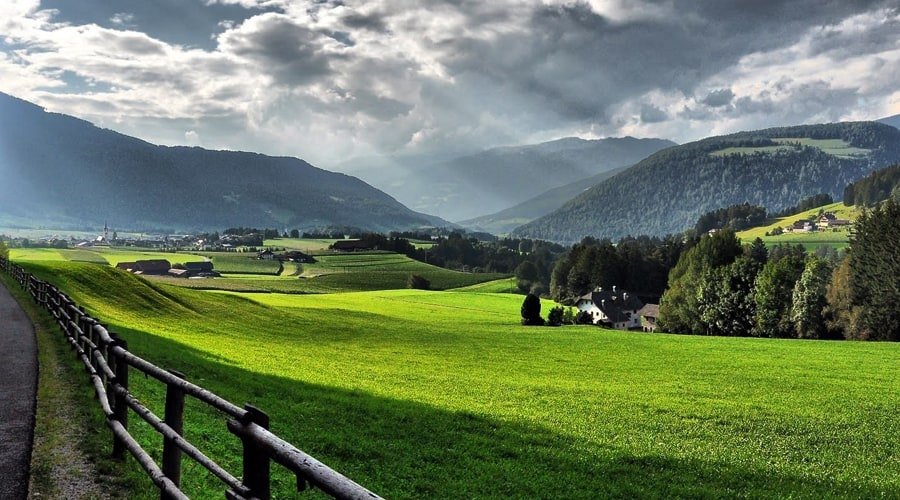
[737, 202, 859, 251]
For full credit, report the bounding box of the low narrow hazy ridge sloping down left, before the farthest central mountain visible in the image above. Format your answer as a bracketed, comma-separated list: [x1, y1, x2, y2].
[459, 167, 628, 234]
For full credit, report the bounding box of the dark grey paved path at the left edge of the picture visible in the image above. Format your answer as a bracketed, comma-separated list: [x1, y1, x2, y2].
[0, 283, 37, 500]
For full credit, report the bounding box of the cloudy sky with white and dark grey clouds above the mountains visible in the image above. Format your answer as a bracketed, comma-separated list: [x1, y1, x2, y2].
[0, 0, 900, 168]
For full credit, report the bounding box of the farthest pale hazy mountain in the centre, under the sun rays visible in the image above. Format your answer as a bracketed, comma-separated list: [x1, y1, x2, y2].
[341, 137, 675, 221]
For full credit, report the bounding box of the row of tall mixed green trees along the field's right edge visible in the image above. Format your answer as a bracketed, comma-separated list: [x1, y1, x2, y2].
[659, 200, 900, 340]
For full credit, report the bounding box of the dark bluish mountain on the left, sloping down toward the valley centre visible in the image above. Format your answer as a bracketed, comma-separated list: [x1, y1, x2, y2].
[0, 94, 447, 230]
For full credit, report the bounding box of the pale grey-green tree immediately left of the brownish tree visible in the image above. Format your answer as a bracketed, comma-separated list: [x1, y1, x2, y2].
[791, 257, 831, 339]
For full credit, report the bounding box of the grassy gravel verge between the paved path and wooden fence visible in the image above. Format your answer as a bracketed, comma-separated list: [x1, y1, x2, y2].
[0, 273, 142, 499]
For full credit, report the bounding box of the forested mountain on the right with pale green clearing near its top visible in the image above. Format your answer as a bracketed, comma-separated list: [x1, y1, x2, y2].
[513, 122, 900, 242]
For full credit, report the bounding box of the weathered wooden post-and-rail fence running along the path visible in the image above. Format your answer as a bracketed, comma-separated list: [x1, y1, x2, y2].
[0, 258, 379, 500]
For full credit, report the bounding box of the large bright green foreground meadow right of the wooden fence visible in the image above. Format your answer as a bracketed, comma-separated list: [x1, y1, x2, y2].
[14, 262, 900, 498]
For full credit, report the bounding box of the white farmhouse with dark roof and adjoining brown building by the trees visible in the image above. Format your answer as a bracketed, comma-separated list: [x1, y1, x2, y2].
[575, 286, 659, 332]
